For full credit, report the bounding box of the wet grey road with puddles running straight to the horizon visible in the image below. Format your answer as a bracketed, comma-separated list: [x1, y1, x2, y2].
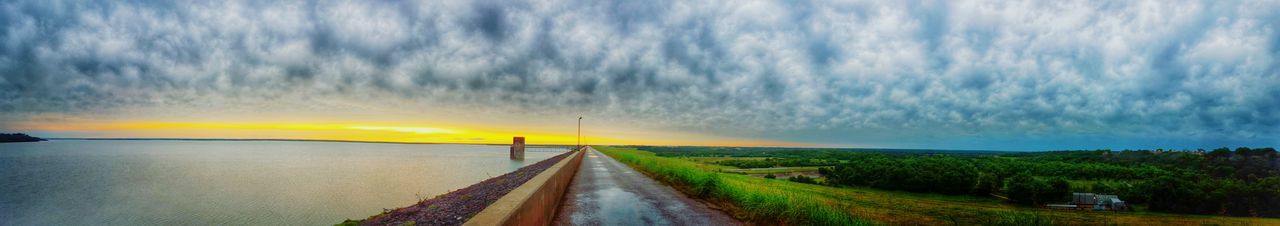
[554, 148, 741, 225]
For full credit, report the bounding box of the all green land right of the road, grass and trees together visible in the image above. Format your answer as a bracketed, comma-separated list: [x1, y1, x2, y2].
[599, 146, 1280, 225]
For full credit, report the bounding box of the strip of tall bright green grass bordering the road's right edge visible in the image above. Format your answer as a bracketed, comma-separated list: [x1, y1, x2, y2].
[596, 147, 874, 225]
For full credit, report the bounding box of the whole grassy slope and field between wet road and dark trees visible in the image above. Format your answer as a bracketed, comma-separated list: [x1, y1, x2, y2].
[596, 147, 1280, 225]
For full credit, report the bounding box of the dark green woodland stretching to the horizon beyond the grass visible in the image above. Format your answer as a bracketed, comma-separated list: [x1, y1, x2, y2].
[657, 147, 1280, 217]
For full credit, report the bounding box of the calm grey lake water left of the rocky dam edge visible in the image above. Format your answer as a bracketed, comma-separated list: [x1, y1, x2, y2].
[0, 140, 559, 225]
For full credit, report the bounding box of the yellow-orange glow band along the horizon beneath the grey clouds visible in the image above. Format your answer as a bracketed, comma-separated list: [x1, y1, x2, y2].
[10, 121, 804, 147]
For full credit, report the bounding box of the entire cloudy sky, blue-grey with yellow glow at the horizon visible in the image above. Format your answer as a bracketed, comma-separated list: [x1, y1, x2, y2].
[0, 0, 1280, 151]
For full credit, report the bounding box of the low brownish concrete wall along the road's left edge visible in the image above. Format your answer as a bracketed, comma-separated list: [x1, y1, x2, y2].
[462, 145, 585, 226]
